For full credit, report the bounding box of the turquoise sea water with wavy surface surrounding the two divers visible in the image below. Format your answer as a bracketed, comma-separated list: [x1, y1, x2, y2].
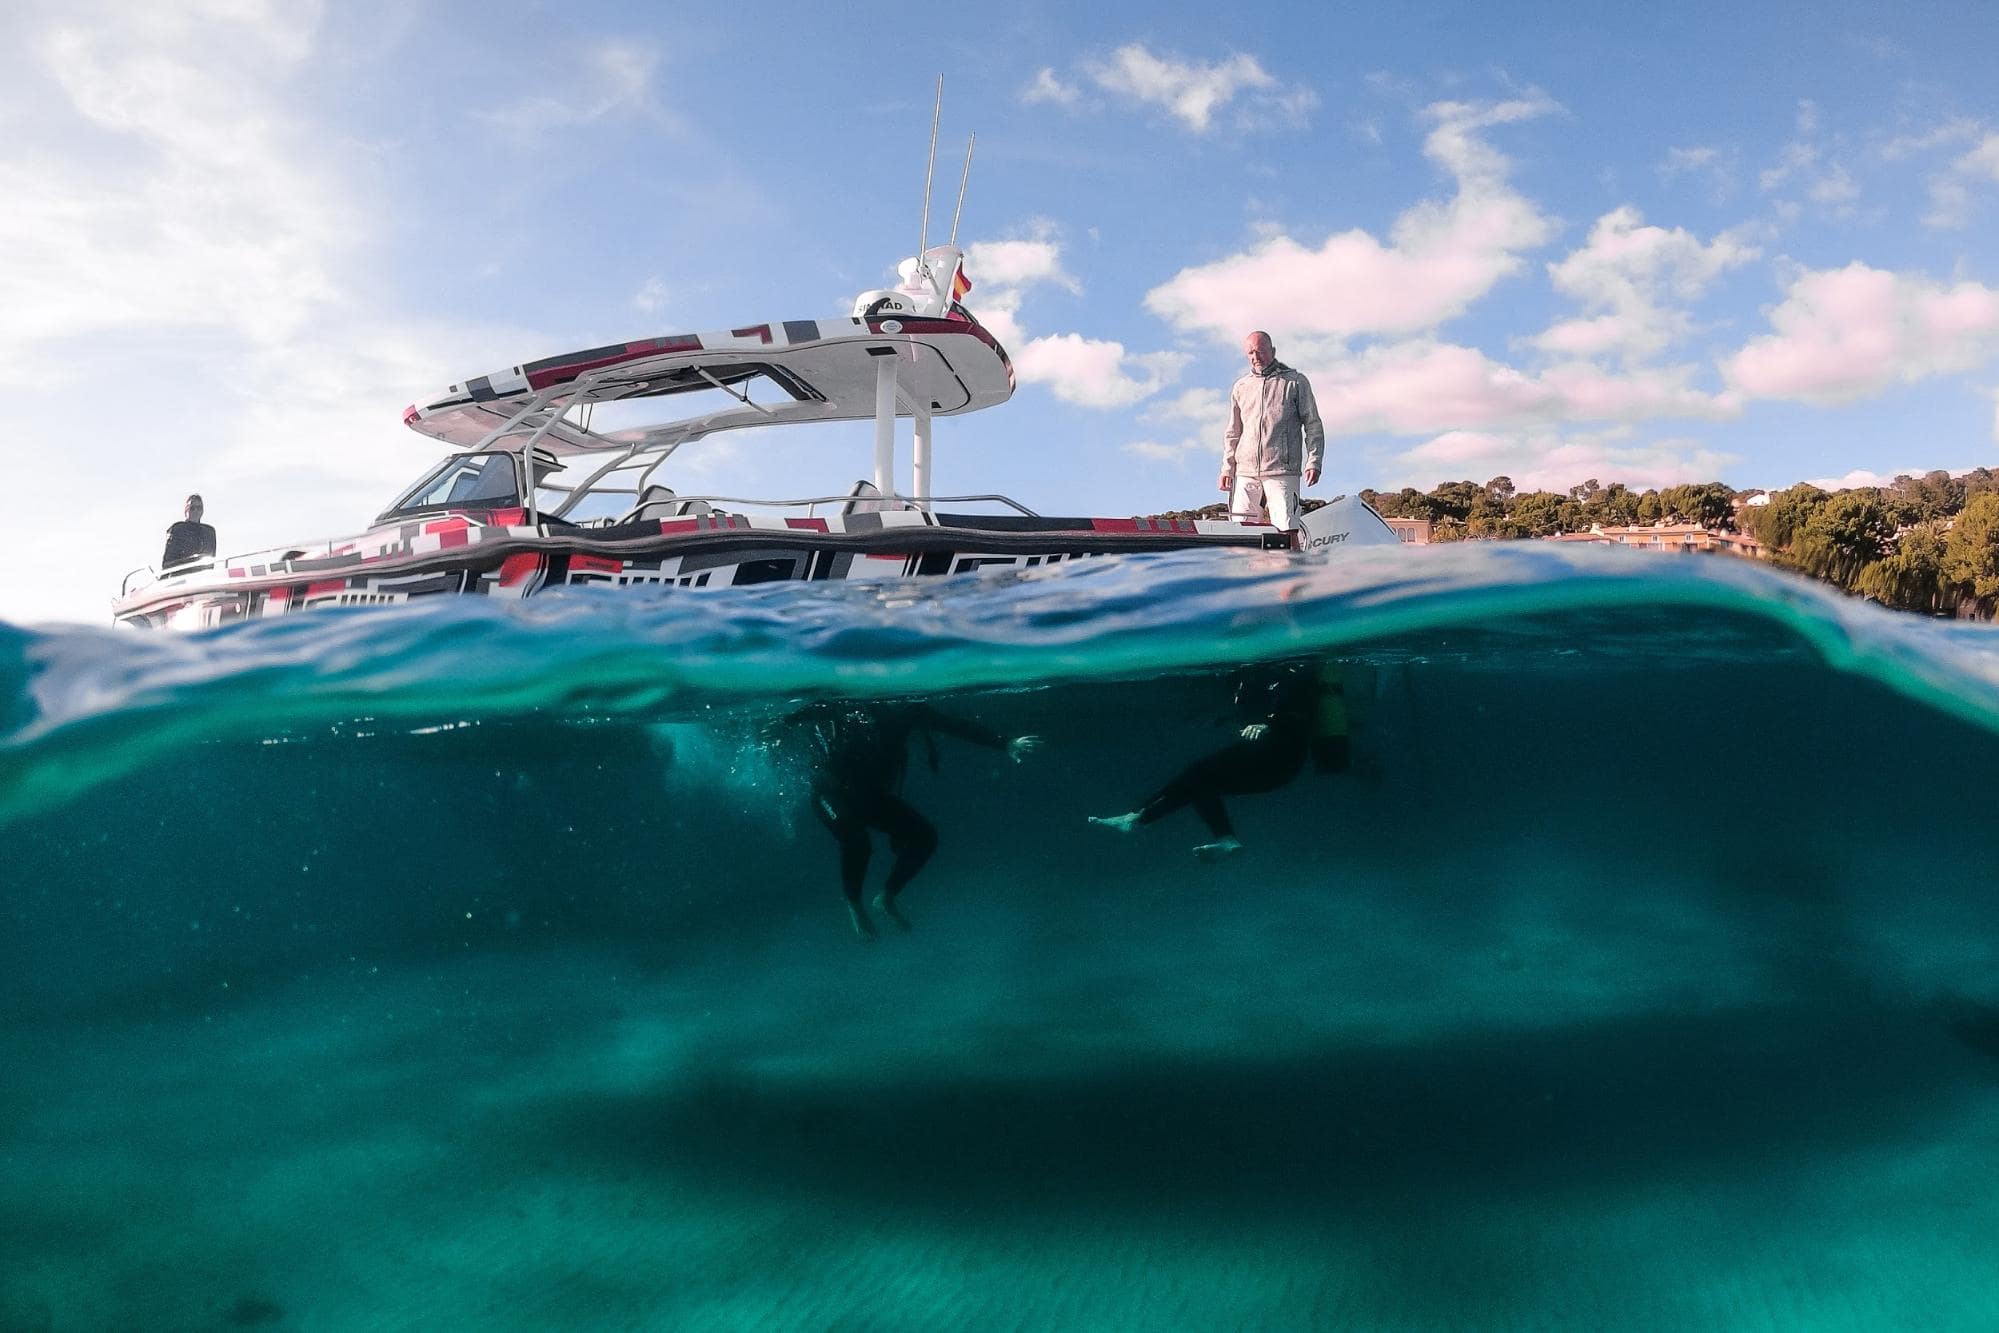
[0, 544, 1999, 1329]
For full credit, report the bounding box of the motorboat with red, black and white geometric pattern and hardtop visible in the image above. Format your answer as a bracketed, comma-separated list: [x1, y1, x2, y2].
[112, 246, 1395, 630]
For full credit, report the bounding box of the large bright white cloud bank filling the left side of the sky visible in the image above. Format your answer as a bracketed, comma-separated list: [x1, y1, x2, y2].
[0, 0, 543, 622]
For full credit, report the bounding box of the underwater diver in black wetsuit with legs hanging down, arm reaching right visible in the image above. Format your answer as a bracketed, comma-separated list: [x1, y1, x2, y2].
[788, 701, 1041, 939]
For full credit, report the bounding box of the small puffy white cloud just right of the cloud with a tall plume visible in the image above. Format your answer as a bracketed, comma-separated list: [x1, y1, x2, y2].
[1531, 204, 1759, 358]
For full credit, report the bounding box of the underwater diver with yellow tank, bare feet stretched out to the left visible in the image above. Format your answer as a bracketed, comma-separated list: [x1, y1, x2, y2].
[1089, 662, 1347, 861]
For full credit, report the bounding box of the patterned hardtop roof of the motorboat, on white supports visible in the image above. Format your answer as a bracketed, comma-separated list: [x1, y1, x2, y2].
[402, 312, 1013, 454]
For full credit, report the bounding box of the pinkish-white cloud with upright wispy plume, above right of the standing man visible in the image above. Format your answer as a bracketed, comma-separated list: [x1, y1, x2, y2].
[1145, 94, 1555, 340]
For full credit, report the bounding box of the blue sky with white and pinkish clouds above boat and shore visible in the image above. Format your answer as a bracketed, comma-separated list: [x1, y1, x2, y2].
[0, 0, 1999, 624]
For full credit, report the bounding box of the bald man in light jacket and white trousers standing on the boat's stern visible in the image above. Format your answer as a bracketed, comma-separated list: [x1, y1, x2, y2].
[1221, 330, 1325, 530]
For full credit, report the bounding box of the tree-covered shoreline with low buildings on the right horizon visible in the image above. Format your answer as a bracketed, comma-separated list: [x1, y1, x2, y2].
[1361, 468, 1999, 620]
